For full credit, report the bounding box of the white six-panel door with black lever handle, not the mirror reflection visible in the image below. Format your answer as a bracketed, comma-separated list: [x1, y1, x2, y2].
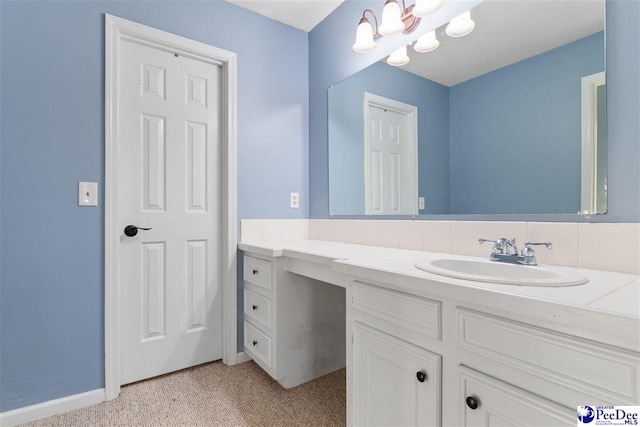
[117, 37, 222, 384]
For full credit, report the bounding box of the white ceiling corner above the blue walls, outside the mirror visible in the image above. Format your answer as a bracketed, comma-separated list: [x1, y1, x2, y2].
[226, 0, 344, 33]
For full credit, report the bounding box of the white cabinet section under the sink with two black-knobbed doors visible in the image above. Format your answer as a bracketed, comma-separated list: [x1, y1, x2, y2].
[347, 277, 640, 426]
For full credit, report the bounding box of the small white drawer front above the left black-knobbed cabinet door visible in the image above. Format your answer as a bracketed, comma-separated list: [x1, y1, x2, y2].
[351, 281, 441, 340]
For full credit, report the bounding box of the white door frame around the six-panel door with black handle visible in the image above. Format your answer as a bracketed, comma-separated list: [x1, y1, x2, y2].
[104, 14, 238, 400]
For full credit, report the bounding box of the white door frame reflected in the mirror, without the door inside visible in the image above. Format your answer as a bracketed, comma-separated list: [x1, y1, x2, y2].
[362, 92, 418, 215]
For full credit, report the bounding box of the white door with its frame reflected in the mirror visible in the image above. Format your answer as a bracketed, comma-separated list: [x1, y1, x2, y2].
[364, 94, 418, 215]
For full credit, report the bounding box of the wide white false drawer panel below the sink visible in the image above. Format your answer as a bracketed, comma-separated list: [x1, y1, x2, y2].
[453, 306, 640, 412]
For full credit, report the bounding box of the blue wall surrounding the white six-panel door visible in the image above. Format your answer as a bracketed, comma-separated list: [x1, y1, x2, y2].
[0, 1, 309, 411]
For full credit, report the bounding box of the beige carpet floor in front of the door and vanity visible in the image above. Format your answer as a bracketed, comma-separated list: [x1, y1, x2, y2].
[24, 362, 346, 426]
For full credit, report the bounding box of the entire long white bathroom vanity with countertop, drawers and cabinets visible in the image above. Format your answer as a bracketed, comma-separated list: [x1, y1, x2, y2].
[239, 240, 640, 426]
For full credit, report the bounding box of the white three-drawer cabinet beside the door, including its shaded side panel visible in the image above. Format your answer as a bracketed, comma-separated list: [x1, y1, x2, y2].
[242, 253, 346, 388]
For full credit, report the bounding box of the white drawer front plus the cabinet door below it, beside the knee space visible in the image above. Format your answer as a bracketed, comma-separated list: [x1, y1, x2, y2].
[347, 282, 442, 426]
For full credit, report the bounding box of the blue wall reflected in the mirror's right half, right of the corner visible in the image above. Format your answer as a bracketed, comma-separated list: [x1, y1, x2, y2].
[449, 32, 604, 214]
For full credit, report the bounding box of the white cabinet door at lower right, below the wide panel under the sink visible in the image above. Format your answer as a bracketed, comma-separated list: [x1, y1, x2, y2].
[459, 366, 576, 427]
